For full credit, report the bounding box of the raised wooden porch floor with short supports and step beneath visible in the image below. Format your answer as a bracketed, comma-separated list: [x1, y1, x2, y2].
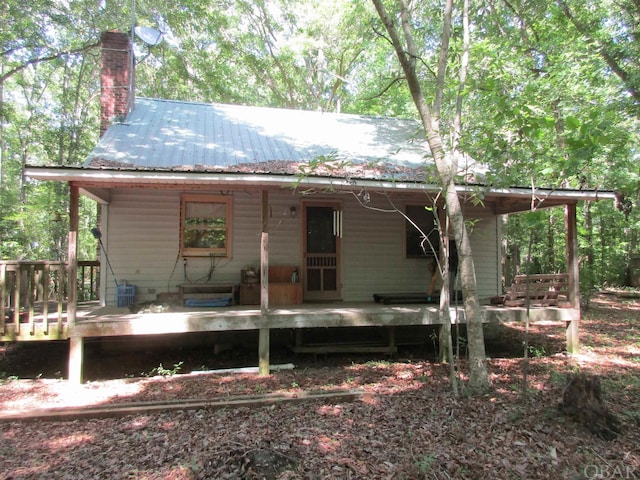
[0, 288, 580, 382]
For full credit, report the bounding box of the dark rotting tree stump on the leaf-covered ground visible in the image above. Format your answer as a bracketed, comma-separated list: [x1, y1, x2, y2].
[560, 373, 620, 440]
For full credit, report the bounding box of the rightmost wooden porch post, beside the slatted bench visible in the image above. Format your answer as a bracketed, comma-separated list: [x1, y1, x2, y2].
[565, 203, 582, 354]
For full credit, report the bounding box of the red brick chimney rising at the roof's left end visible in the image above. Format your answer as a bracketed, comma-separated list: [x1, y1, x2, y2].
[100, 30, 135, 136]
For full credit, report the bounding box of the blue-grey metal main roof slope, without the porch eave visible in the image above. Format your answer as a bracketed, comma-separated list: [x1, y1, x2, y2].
[84, 97, 482, 181]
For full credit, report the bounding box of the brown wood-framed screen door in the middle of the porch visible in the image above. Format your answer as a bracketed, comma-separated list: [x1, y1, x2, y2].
[303, 203, 342, 301]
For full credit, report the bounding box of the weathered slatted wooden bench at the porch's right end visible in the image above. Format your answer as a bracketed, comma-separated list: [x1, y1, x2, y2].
[502, 273, 569, 307]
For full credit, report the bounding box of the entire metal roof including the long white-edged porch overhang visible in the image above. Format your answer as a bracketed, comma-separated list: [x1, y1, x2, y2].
[25, 97, 616, 213]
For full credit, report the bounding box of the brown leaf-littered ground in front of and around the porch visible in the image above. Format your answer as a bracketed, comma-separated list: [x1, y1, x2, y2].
[0, 295, 640, 479]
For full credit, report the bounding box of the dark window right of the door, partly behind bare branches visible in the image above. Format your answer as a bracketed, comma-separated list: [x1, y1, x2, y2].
[405, 205, 440, 258]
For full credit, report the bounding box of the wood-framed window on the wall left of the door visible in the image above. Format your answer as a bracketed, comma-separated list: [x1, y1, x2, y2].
[180, 195, 231, 257]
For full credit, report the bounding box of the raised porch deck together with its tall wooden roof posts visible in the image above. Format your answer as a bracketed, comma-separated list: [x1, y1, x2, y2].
[0, 182, 596, 382]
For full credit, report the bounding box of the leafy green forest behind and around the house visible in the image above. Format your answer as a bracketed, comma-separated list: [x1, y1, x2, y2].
[0, 0, 640, 294]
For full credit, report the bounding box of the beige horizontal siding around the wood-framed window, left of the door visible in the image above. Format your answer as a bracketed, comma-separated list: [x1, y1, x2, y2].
[104, 190, 300, 304]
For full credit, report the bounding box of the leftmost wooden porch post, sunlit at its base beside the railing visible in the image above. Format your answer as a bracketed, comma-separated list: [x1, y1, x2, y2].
[67, 183, 84, 383]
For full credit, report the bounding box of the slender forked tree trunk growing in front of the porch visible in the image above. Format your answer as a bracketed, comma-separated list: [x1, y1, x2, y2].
[373, 0, 489, 393]
